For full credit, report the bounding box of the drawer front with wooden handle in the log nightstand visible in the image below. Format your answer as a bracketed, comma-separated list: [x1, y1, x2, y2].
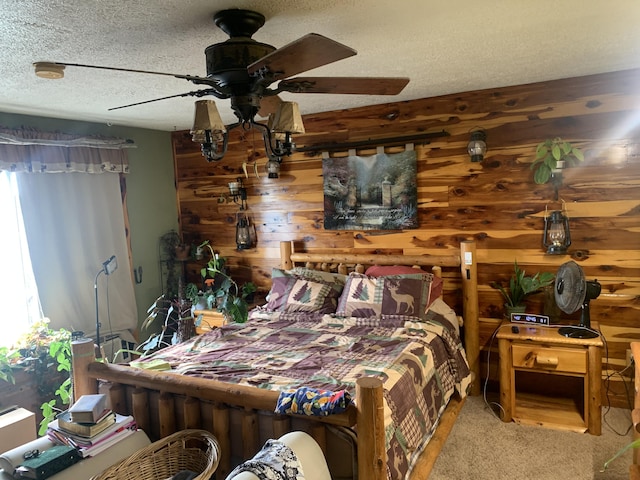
[512, 344, 587, 374]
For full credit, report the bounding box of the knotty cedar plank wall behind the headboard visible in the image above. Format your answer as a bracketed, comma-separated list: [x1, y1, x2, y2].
[173, 66, 640, 406]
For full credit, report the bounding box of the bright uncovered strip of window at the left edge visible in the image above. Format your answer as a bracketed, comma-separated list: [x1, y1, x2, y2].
[0, 171, 43, 347]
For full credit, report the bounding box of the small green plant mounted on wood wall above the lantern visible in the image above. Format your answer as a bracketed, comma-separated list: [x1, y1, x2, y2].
[531, 137, 584, 184]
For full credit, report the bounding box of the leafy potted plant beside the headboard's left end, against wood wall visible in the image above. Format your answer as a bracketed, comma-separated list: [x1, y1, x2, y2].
[187, 240, 256, 323]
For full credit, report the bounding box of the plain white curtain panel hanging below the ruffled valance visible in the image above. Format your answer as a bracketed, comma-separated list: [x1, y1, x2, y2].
[16, 173, 138, 338]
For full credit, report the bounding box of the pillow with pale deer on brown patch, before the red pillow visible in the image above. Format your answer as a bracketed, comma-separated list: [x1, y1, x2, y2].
[336, 273, 433, 319]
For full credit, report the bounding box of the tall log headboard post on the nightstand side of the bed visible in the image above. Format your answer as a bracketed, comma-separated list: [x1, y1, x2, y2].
[460, 240, 480, 395]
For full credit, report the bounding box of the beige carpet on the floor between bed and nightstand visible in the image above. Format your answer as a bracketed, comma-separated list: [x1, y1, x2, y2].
[429, 397, 633, 480]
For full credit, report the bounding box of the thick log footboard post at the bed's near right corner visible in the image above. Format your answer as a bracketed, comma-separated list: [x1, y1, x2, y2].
[356, 377, 387, 480]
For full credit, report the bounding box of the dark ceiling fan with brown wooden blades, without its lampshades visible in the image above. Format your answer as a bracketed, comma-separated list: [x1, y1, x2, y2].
[34, 9, 409, 160]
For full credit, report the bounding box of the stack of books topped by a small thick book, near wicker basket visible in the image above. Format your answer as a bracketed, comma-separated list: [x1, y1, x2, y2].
[47, 394, 137, 458]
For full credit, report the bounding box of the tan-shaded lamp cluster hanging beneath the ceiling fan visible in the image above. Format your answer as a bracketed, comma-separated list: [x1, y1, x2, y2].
[191, 100, 304, 162]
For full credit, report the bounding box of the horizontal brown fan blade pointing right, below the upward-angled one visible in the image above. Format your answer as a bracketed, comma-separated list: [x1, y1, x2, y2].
[278, 77, 409, 95]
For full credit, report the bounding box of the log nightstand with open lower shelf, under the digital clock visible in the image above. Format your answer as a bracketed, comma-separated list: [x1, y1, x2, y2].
[496, 322, 603, 435]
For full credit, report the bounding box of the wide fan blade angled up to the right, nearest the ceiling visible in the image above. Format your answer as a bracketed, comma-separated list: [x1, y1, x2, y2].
[247, 33, 357, 81]
